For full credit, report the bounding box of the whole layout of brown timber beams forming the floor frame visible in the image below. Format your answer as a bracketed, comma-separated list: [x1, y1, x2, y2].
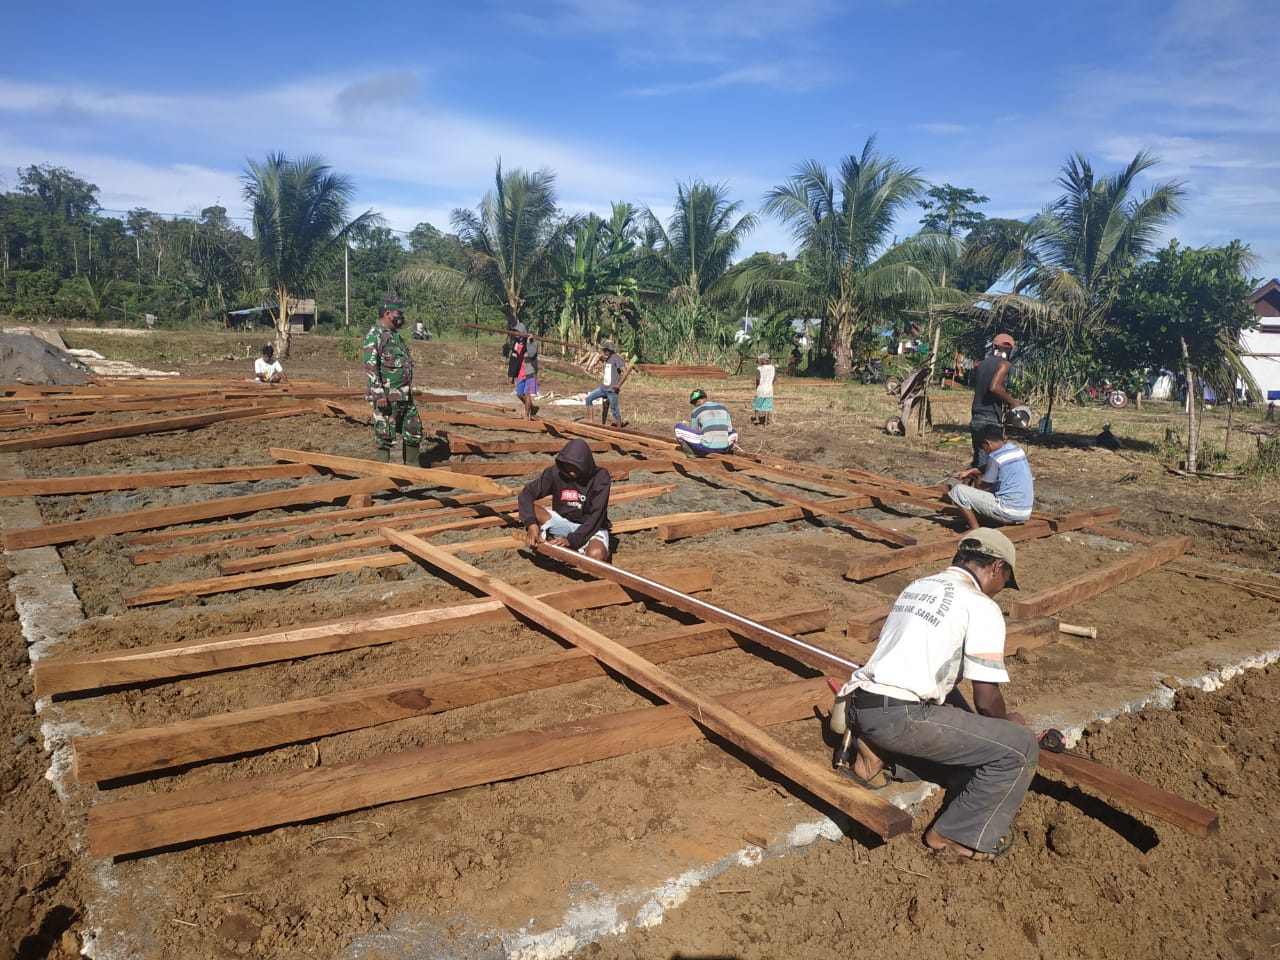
[0, 378, 1190, 856]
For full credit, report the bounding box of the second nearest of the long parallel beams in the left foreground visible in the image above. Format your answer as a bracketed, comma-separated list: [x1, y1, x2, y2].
[72, 607, 827, 783]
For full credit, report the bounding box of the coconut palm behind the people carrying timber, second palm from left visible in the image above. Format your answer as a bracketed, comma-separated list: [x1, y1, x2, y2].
[399, 161, 579, 329]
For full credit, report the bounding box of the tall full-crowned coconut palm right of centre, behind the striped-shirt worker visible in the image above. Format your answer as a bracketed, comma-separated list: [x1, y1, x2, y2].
[753, 137, 946, 376]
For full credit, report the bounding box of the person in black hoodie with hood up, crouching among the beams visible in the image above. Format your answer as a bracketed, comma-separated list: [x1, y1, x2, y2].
[518, 438, 613, 562]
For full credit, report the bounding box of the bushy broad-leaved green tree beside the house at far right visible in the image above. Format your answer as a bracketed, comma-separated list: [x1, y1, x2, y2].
[1108, 241, 1257, 472]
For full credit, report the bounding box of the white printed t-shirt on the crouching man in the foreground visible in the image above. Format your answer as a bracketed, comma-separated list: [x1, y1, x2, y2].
[840, 567, 1009, 704]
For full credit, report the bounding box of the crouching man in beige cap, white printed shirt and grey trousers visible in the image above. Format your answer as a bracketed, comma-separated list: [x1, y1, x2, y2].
[836, 529, 1039, 860]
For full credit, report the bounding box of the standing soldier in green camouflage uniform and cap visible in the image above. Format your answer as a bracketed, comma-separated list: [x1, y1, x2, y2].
[365, 302, 422, 467]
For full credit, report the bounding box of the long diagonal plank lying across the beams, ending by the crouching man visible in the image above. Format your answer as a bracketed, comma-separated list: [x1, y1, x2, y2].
[383, 530, 911, 837]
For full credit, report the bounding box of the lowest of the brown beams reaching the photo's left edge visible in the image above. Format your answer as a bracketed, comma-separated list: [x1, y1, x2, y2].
[4, 476, 396, 550]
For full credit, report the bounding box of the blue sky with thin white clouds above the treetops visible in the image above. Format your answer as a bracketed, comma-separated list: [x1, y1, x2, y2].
[0, 0, 1280, 285]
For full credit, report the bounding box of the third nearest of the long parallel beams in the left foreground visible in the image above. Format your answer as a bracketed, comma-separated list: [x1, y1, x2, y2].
[33, 567, 712, 696]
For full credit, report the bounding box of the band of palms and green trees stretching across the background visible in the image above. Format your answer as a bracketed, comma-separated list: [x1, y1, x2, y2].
[0, 151, 1251, 417]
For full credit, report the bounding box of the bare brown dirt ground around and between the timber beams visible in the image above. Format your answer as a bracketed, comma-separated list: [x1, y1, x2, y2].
[0, 343, 1280, 960]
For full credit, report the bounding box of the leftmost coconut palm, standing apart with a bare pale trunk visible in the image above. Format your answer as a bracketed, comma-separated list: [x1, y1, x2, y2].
[242, 154, 381, 357]
